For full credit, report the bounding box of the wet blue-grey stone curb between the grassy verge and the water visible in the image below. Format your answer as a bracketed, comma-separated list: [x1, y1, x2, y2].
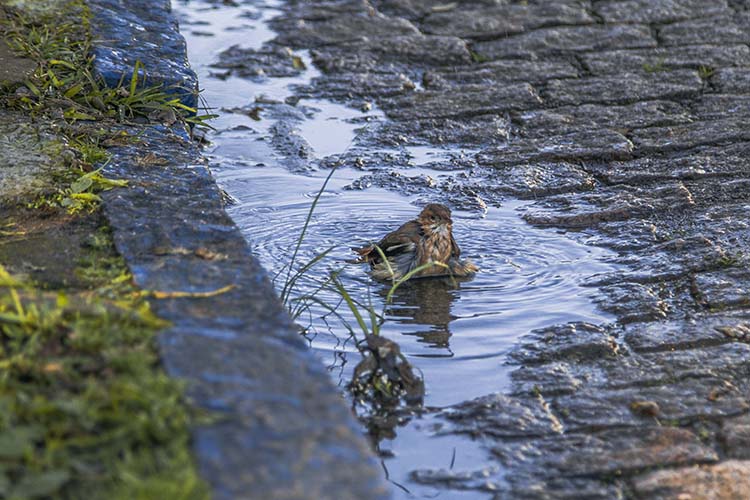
[89, 0, 389, 499]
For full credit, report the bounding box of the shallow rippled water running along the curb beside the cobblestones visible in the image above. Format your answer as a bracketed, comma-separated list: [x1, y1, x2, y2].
[175, 1, 614, 498]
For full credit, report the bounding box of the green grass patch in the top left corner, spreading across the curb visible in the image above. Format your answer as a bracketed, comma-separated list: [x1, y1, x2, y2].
[0, 0, 215, 125]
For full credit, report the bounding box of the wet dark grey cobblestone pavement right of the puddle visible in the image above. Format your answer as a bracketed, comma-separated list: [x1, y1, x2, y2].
[254, 0, 750, 499]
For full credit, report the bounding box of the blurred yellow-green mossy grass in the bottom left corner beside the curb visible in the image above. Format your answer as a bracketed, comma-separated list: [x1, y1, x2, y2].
[0, 240, 208, 499]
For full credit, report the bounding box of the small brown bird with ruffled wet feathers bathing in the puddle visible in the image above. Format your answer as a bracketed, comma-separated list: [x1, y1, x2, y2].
[352, 203, 479, 281]
